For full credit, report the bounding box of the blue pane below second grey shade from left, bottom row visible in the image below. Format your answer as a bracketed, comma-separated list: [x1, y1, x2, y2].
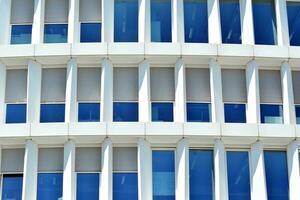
[37, 173, 63, 200]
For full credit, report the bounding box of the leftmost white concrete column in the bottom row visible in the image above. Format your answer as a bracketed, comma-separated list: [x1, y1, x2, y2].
[22, 140, 38, 200]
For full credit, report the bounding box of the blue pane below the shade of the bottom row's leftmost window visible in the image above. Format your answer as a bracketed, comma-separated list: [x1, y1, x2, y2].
[2, 174, 23, 200]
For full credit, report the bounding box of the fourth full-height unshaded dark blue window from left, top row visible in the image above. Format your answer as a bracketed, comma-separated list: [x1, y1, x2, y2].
[220, 0, 242, 44]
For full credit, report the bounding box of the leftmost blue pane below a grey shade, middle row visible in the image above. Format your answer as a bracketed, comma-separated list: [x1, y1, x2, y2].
[6, 104, 26, 123]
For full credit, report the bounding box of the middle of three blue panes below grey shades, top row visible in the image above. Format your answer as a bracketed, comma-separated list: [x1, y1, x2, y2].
[44, 24, 68, 43]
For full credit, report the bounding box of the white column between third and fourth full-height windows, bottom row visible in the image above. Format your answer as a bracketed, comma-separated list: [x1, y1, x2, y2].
[250, 142, 268, 200]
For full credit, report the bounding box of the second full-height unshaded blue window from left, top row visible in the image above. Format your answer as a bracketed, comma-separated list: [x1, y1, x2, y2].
[151, 0, 172, 42]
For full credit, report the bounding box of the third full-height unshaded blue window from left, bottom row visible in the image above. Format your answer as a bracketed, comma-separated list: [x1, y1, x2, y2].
[227, 151, 251, 200]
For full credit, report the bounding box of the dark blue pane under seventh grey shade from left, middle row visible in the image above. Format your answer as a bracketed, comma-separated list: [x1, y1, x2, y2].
[224, 103, 246, 123]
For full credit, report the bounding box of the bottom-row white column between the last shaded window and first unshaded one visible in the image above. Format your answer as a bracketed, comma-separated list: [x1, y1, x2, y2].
[138, 138, 152, 200]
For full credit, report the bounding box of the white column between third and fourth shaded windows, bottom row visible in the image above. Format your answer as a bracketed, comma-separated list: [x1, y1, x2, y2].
[100, 138, 113, 200]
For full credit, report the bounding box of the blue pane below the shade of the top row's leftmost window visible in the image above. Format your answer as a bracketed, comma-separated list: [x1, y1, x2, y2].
[10, 25, 32, 44]
